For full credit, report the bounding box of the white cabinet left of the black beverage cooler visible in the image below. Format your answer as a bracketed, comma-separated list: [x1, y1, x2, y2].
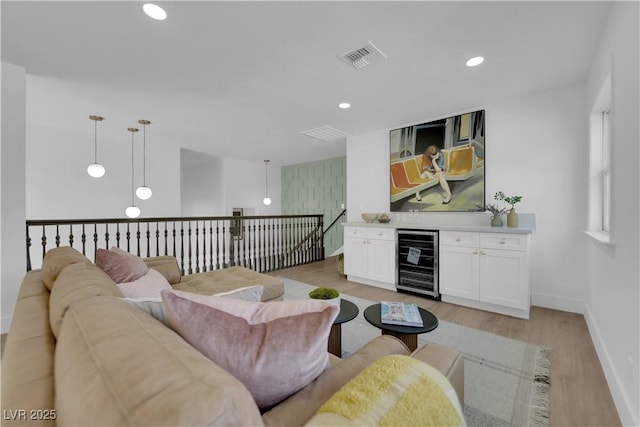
[344, 227, 396, 290]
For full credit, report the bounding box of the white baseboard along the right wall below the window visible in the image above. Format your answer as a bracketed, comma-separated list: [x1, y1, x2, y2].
[584, 303, 640, 426]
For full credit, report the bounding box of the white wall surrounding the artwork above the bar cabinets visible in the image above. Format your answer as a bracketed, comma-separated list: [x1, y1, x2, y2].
[347, 85, 587, 312]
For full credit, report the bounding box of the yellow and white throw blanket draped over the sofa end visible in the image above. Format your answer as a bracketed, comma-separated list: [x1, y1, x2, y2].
[306, 355, 466, 427]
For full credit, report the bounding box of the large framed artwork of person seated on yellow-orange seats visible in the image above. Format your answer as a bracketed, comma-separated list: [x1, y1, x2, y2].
[389, 110, 485, 212]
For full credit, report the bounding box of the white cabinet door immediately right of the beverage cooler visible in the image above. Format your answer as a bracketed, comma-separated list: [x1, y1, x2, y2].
[440, 246, 480, 300]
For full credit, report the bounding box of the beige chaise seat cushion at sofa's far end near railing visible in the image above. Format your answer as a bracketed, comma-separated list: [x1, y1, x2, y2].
[173, 266, 284, 301]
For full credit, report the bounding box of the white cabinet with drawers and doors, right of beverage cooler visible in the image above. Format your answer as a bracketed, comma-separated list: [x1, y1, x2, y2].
[440, 231, 531, 318]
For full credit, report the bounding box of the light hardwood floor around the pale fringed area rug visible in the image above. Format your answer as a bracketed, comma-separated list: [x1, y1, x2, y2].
[270, 258, 621, 427]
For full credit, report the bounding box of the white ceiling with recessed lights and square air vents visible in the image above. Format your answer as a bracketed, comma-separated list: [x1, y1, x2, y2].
[1, 1, 610, 164]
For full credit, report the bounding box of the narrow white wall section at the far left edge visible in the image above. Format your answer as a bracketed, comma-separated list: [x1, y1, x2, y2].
[0, 62, 26, 333]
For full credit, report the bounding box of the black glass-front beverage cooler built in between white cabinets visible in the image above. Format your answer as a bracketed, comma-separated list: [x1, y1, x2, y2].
[396, 229, 440, 300]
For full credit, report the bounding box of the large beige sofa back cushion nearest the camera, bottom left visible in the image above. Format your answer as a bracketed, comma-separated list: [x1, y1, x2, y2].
[54, 296, 262, 426]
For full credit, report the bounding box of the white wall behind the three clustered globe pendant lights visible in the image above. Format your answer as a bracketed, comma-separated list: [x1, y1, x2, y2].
[26, 75, 180, 219]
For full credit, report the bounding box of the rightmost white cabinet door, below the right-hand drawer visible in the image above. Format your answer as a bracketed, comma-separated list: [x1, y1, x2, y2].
[479, 249, 529, 309]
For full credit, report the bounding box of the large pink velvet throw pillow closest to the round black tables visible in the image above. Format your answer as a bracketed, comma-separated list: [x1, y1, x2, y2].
[162, 290, 339, 408]
